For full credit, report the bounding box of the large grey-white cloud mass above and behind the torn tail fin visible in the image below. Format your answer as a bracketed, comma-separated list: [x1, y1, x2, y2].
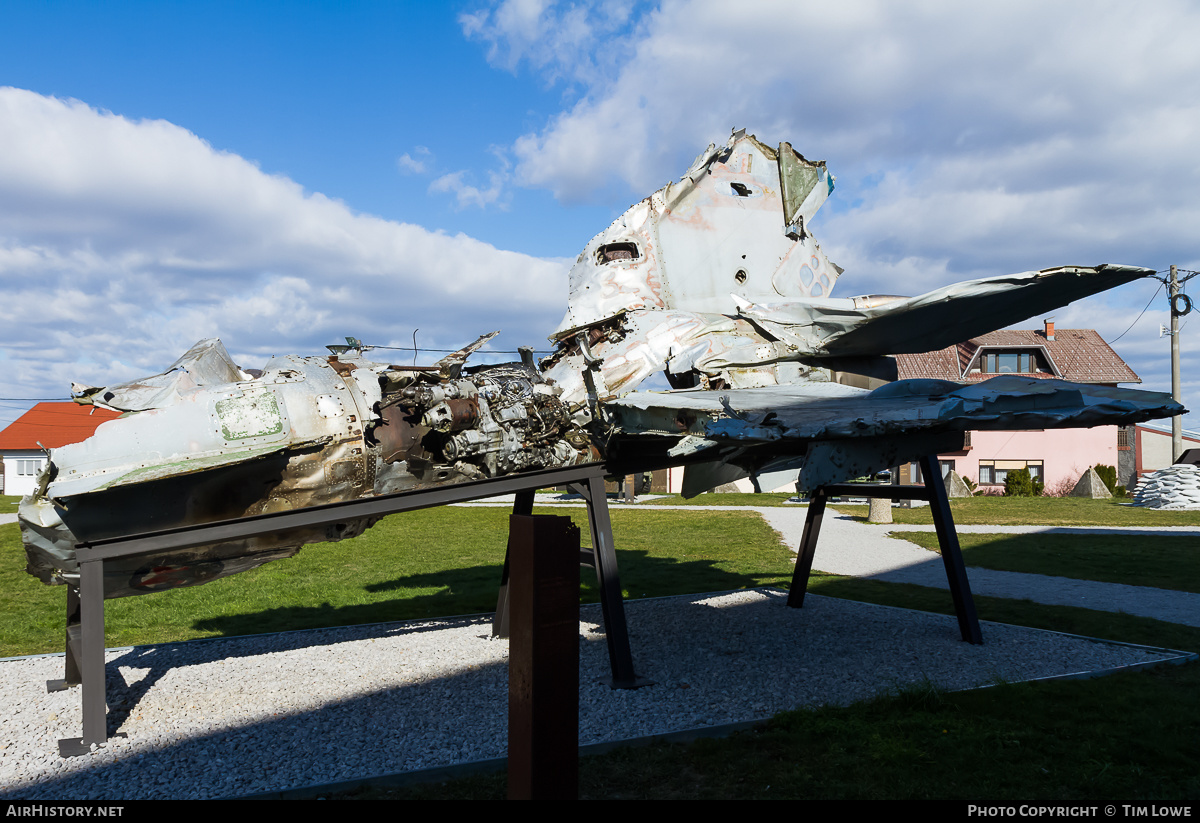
[488, 0, 1200, 290]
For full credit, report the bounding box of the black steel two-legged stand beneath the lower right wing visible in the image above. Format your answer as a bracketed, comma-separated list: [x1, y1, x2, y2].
[787, 455, 983, 644]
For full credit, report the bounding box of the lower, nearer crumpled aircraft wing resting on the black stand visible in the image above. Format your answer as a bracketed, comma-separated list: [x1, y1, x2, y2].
[605, 376, 1186, 497]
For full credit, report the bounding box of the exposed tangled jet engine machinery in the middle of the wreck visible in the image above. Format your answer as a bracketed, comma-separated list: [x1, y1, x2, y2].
[372, 364, 599, 483]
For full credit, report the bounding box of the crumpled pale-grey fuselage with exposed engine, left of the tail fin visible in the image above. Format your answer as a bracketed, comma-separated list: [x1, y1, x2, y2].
[27, 335, 598, 597]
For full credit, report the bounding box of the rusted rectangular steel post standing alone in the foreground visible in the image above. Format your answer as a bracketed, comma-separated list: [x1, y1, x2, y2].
[509, 515, 580, 800]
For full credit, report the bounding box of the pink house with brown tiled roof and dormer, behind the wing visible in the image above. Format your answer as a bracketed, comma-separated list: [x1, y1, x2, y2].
[896, 320, 1137, 492]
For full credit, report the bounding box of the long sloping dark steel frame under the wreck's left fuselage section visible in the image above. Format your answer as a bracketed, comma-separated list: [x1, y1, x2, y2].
[46, 463, 646, 757]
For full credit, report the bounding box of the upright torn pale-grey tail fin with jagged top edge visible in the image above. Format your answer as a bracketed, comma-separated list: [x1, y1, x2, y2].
[552, 131, 841, 340]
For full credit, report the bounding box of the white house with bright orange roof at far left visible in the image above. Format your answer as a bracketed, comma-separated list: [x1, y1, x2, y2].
[0, 403, 120, 497]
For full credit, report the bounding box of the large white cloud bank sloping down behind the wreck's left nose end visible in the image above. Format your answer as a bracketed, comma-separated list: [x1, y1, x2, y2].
[0, 88, 565, 412]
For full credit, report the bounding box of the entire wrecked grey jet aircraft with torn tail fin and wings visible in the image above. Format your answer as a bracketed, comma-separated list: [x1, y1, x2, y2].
[20, 132, 1183, 597]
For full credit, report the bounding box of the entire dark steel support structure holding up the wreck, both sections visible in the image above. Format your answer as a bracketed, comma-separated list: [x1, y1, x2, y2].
[47, 456, 983, 757]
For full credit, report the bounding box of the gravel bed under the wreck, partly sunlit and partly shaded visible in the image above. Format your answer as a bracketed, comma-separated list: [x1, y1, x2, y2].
[0, 590, 1169, 800]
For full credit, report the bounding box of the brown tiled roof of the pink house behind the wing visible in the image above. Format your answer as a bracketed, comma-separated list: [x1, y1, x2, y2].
[895, 329, 1141, 383]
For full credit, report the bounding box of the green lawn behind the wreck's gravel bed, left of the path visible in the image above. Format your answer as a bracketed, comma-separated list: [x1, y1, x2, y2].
[0, 507, 791, 656]
